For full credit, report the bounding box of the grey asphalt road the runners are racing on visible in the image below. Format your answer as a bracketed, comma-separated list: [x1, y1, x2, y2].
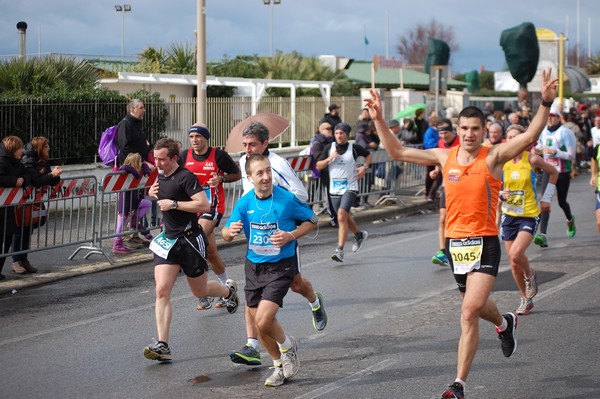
[0, 175, 600, 399]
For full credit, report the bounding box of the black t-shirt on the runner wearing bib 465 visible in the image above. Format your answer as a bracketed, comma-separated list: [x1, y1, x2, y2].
[158, 166, 202, 238]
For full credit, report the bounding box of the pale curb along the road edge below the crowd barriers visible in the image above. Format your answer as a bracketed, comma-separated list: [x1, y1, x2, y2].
[0, 196, 437, 295]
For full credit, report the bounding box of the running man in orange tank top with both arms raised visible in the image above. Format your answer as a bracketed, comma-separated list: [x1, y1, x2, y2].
[365, 69, 558, 398]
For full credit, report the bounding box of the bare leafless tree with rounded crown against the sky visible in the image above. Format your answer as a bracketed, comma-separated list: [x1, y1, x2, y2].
[396, 18, 459, 65]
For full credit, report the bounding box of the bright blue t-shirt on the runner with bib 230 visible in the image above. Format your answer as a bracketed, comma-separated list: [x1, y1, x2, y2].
[225, 186, 317, 263]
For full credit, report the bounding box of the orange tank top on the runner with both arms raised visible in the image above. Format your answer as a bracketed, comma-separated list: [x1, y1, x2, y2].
[443, 146, 502, 238]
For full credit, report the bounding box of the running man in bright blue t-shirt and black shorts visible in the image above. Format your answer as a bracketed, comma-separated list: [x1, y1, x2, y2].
[221, 154, 318, 386]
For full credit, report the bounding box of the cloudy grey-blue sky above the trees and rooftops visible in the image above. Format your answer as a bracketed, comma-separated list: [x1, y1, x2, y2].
[0, 0, 600, 74]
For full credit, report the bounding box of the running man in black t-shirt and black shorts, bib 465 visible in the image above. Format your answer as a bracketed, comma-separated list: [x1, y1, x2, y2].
[144, 139, 238, 362]
